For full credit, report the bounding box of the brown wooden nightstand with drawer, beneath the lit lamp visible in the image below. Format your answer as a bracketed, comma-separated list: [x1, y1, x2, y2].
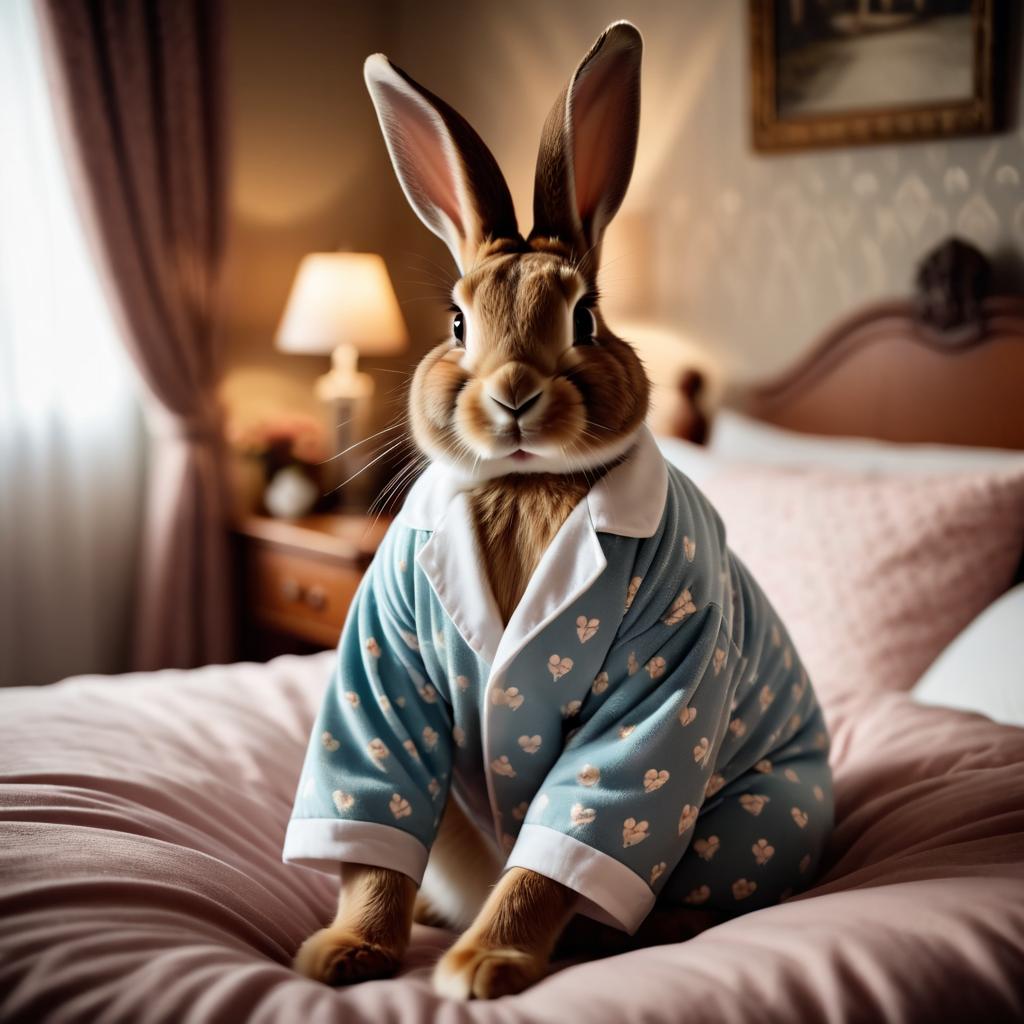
[233, 515, 389, 660]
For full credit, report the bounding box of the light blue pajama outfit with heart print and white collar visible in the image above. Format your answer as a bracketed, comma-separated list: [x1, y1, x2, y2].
[285, 430, 833, 931]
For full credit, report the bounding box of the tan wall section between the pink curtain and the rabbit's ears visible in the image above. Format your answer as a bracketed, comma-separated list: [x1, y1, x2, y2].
[223, 0, 390, 430]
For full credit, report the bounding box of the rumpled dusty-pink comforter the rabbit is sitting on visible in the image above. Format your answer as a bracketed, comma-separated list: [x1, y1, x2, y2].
[0, 654, 1024, 1024]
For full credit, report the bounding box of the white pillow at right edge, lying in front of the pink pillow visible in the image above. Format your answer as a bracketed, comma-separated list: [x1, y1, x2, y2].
[912, 584, 1024, 726]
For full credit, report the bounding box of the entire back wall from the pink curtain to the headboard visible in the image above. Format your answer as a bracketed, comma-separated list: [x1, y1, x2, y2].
[225, 0, 1024, 440]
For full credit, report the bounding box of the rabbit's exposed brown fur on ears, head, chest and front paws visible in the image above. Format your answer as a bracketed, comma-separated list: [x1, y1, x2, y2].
[296, 23, 648, 998]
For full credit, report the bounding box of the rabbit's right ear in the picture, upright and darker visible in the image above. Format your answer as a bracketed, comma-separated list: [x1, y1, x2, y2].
[530, 22, 643, 265]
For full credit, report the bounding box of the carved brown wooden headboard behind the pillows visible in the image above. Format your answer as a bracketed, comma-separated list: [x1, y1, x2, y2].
[684, 241, 1024, 450]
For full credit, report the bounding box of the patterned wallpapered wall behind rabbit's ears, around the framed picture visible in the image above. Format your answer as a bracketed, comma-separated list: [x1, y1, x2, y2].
[388, 0, 1024, 378]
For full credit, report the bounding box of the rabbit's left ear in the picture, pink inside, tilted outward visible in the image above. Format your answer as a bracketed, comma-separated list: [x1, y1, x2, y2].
[364, 53, 519, 272]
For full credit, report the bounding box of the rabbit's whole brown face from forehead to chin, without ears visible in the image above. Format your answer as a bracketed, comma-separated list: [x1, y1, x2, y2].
[410, 260, 648, 480]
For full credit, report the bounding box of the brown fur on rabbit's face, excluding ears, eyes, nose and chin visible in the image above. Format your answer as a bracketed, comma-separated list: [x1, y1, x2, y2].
[410, 240, 649, 471]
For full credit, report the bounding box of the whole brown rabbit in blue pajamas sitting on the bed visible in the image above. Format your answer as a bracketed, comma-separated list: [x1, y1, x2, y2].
[286, 22, 830, 998]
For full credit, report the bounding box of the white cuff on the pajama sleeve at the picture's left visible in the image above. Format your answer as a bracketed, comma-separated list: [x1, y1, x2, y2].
[282, 818, 427, 885]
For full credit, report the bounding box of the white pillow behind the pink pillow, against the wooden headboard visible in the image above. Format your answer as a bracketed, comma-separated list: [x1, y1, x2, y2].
[708, 409, 1024, 476]
